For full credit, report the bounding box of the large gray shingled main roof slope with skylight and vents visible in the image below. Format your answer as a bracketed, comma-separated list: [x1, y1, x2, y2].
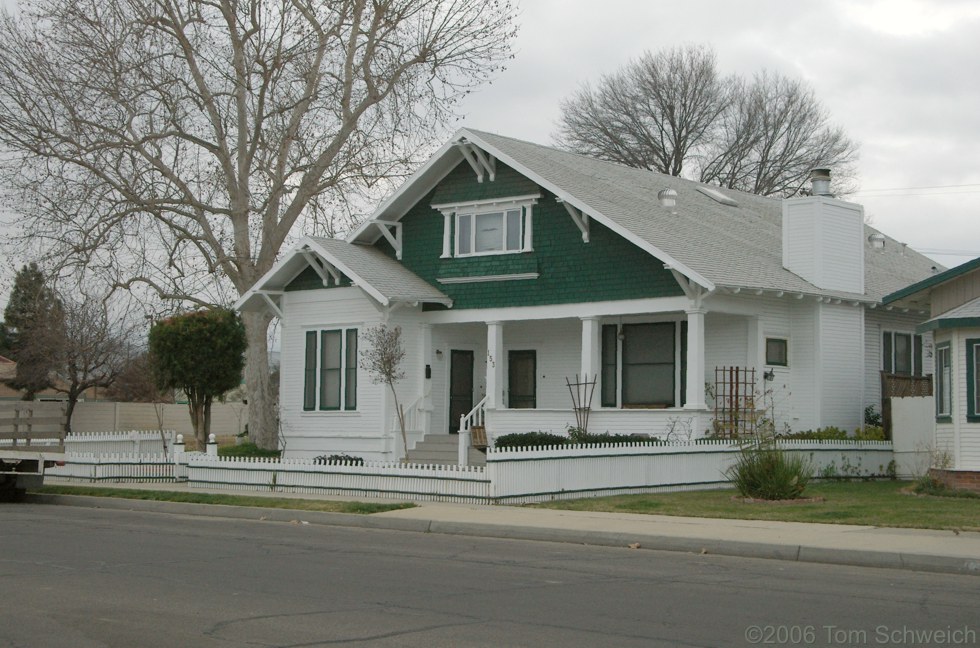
[462, 129, 941, 301]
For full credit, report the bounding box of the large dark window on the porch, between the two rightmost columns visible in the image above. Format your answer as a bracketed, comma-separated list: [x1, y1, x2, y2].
[600, 322, 686, 408]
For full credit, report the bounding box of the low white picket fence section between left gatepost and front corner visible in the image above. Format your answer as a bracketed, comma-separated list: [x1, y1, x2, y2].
[187, 456, 490, 502]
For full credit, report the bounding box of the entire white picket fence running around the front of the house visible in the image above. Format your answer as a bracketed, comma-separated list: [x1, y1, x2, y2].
[50, 432, 895, 504]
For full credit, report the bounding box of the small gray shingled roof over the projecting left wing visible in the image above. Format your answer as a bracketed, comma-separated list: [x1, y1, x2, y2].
[307, 236, 452, 305]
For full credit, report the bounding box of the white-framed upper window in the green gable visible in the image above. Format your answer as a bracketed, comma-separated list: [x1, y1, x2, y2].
[432, 196, 538, 259]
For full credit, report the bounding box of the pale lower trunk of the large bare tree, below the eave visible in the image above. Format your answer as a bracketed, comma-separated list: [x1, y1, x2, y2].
[242, 311, 279, 450]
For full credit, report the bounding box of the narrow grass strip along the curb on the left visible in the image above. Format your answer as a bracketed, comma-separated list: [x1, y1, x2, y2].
[35, 485, 415, 515]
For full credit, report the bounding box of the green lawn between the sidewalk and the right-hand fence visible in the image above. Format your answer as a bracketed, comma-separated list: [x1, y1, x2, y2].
[533, 481, 980, 531]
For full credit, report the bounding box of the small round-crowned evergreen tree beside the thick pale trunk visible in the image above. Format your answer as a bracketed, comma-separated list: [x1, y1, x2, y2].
[149, 308, 247, 447]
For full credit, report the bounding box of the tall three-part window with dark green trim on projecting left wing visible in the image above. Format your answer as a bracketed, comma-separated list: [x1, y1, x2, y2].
[303, 329, 357, 411]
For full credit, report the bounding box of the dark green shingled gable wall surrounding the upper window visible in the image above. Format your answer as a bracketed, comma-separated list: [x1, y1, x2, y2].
[378, 161, 683, 309]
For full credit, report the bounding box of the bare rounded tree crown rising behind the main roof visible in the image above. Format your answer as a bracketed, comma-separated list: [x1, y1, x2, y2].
[555, 46, 857, 196]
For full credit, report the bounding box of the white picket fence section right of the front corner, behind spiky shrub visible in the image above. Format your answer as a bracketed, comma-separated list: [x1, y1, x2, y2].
[487, 441, 893, 504]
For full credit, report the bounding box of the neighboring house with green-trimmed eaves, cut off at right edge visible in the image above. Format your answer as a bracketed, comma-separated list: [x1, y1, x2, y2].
[882, 258, 980, 491]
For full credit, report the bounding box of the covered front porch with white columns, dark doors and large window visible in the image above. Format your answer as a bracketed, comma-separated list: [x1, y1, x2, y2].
[392, 299, 758, 463]
